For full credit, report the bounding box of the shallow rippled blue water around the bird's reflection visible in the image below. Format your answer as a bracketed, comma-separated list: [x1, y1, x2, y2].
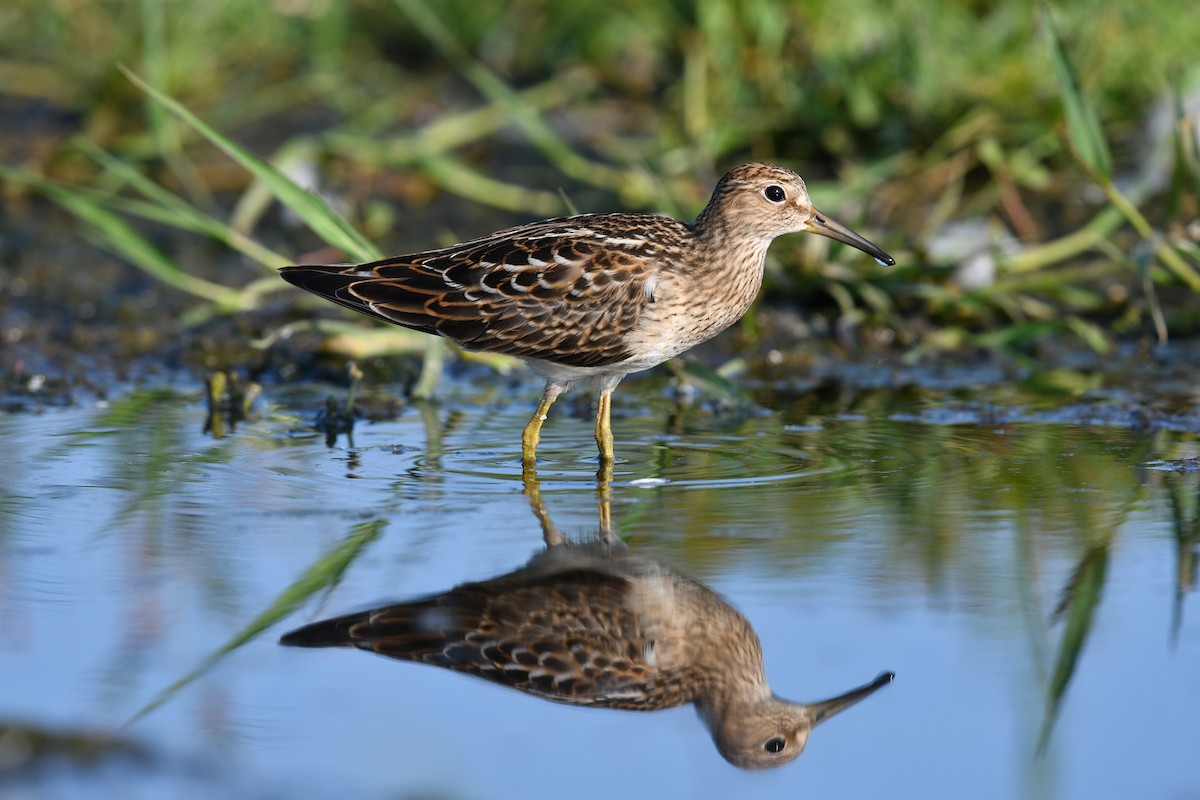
[0, 380, 1200, 798]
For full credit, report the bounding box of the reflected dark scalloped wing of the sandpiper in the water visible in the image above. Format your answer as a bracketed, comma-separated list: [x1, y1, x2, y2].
[282, 569, 665, 709]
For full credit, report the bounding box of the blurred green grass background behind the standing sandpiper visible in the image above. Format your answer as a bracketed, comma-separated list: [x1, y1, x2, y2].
[0, 0, 1200, 364]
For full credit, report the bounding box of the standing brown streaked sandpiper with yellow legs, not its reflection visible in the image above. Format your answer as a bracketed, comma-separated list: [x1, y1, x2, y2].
[280, 163, 895, 465]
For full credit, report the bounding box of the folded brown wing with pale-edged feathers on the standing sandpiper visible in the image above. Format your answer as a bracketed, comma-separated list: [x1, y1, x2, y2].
[281, 215, 685, 367]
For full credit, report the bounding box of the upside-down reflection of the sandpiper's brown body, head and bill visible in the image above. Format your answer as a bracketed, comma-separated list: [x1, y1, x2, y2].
[281, 545, 892, 768]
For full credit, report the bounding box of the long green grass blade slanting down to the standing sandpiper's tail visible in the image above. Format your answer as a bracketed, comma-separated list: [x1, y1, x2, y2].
[121, 66, 383, 261]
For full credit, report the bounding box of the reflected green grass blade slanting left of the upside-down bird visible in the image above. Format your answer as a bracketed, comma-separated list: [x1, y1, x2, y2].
[125, 519, 388, 727]
